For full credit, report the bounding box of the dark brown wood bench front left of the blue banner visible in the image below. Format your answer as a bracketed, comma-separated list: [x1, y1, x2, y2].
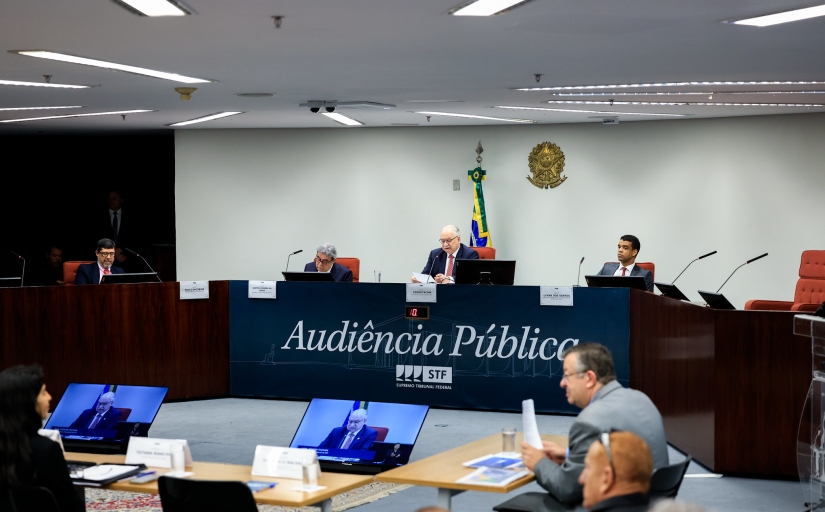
[0, 281, 229, 405]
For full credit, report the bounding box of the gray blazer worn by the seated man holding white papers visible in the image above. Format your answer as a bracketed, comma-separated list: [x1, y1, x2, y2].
[534, 380, 668, 503]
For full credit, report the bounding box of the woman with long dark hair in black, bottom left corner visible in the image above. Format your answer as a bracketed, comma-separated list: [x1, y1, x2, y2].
[0, 365, 86, 512]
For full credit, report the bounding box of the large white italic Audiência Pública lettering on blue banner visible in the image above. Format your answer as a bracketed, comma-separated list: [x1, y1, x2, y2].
[281, 320, 579, 361]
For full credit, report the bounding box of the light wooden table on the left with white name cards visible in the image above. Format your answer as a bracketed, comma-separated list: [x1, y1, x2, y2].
[66, 452, 373, 512]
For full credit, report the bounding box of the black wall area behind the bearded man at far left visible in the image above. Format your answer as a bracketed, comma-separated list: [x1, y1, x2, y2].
[0, 132, 175, 284]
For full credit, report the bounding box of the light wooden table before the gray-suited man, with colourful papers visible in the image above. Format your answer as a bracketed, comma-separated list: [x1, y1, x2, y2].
[375, 432, 567, 510]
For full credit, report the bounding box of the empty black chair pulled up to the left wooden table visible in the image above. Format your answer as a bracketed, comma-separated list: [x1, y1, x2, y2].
[158, 476, 258, 512]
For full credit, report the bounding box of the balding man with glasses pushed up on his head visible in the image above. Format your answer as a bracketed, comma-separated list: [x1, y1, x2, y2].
[579, 432, 653, 512]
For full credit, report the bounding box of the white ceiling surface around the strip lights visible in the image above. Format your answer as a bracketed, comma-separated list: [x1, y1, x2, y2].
[0, 0, 825, 134]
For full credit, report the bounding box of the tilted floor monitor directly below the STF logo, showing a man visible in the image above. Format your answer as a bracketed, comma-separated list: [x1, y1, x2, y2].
[289, 398, 430, 475]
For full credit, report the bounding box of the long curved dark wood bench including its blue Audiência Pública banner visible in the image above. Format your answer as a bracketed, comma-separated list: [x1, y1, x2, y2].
[0, 281, 811, 478]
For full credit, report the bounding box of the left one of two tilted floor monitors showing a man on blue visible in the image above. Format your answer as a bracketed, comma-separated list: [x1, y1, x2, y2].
[43, 382, 169, 453]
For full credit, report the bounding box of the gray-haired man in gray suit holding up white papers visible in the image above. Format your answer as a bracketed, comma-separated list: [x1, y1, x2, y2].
[521, 343, 668, 503]
